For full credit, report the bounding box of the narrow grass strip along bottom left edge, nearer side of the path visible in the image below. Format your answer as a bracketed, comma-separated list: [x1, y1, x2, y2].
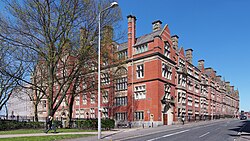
[0, 134, 95, 141]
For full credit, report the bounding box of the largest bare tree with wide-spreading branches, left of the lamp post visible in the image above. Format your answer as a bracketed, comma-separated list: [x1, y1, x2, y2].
[0, 0, 121, 116]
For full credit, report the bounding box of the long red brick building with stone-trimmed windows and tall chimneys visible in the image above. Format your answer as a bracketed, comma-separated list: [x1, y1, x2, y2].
[68, 15, 239, 126]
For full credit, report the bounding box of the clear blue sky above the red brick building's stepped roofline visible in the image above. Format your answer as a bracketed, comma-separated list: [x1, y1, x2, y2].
[118, 0, 250, 111]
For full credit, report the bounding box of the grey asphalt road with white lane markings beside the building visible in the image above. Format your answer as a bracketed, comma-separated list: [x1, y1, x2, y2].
[120, 120, 244, 141]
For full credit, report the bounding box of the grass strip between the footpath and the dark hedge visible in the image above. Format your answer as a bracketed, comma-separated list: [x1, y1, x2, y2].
[0, 129, 97, 135]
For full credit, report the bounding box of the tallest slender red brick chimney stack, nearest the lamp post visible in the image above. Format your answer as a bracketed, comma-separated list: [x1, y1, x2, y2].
[127, 15, 136, 58]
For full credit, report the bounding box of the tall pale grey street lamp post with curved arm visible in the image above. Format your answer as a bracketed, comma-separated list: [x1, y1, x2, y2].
[98, 2, 118, 139]
